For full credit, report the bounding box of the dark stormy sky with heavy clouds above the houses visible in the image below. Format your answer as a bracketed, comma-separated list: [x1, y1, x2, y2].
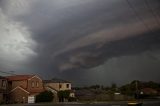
[0, 0, 160, 85]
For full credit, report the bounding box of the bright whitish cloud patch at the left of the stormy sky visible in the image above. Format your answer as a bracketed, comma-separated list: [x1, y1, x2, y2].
[0, 8, 36, 69]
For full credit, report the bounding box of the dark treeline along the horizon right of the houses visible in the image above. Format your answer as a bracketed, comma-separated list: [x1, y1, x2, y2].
[73, 80, 160, 96]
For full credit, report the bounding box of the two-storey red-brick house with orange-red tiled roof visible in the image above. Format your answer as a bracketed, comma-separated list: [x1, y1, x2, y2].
[6, 75, 44, 103]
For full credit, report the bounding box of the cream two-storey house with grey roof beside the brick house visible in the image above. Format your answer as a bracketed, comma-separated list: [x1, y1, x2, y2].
[43, 78, 75, 102]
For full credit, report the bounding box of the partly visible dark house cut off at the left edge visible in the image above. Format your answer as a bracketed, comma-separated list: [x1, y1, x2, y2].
[0, 76, 7, 103]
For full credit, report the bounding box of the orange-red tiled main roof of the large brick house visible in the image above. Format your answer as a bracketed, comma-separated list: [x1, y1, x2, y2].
[6, 75, 34, 81]
